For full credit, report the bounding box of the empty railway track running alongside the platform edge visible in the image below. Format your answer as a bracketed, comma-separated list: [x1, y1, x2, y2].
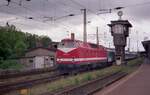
[42, 72, 127, 95]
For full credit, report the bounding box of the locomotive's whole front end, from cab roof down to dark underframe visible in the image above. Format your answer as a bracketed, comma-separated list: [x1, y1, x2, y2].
[56, 39, 79, 73]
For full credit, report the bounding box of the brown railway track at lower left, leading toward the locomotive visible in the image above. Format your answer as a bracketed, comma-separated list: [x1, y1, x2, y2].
[0, 73, 62, 94]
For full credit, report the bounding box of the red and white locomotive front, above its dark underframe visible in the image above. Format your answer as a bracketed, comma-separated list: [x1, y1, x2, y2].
[56, 39, 78, 64]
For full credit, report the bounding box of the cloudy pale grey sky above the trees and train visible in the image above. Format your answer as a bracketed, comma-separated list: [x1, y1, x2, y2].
[0, 0, 150, 51]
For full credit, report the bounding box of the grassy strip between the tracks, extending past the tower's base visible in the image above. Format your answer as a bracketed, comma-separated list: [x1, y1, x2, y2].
[48, 58, 142, 92]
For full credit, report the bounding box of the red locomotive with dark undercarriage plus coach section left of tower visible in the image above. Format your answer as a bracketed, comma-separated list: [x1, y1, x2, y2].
[56, 34, 137, 73]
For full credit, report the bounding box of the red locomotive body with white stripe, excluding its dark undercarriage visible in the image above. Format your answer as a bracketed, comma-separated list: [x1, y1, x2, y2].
[57, 39, 107, 65]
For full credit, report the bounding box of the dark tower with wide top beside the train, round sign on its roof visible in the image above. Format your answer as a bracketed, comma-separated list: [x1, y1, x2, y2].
[108, 11, 132, 65]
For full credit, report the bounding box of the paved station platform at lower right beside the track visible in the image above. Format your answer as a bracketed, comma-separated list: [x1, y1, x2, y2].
[94, 59, 150, 95]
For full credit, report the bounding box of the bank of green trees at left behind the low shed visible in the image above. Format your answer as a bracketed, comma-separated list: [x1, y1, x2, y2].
[0, 24, 51, 68]
